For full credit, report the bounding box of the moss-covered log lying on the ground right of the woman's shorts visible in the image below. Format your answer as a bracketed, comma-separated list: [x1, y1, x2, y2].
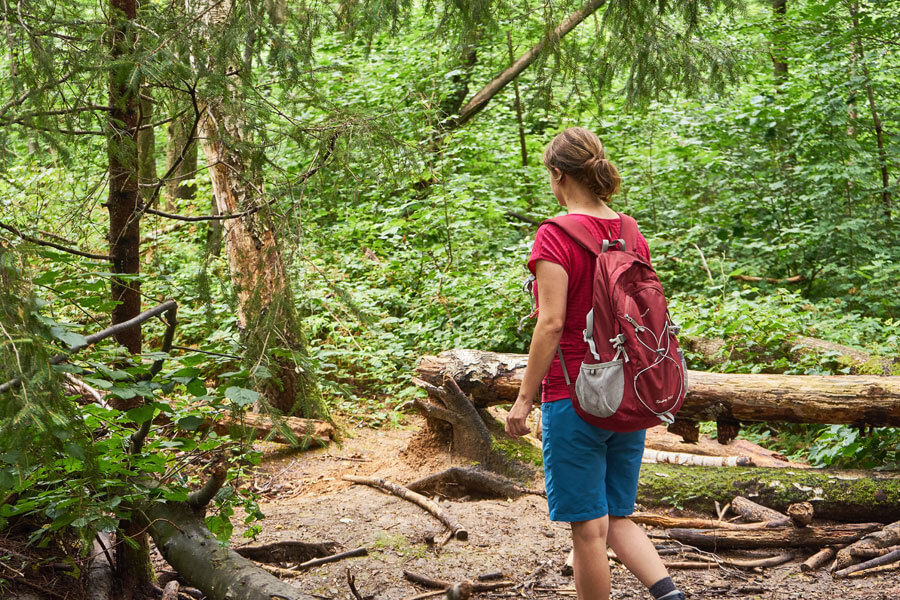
[637, 464, 900, 523]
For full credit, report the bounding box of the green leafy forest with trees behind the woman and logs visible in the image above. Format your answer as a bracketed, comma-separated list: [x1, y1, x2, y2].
[0, 0, 900, 596]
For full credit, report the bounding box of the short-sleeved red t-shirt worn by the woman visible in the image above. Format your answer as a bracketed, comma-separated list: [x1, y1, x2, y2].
[528, 214, 650, 402]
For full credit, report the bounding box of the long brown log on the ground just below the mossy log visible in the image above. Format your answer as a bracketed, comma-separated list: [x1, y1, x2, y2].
[667, 523, 881, 550]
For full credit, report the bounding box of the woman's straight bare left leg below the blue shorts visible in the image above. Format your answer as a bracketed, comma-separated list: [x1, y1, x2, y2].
[572, 517, 609, 600]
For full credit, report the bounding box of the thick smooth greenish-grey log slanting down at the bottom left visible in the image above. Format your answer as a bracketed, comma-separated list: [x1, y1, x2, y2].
[146, 502, 314, 600]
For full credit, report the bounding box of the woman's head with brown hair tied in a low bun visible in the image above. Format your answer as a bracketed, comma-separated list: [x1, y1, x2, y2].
[544, 127, 621, 202]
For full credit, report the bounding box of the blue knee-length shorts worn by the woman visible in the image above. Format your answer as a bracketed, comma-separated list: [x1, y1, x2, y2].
[541, 399, 646, 523]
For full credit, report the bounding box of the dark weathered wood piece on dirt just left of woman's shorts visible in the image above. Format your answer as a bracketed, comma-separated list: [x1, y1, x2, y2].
[406, 467, 546, 498]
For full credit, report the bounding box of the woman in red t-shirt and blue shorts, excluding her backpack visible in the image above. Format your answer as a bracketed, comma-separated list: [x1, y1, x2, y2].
[506, 127, 684, 600]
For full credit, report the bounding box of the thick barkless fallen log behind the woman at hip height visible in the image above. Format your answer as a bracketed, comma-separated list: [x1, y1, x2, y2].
[416, 350, 900, 427]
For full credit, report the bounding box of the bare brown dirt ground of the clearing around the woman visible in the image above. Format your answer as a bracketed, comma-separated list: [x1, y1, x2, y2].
[232, 417, 900, 600]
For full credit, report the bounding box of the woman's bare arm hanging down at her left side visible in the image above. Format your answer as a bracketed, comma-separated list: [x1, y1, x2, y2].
[506, 260, 569, 436]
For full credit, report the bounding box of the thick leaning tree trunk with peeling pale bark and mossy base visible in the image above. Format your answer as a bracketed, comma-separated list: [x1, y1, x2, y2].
[200, 1, 326, 417]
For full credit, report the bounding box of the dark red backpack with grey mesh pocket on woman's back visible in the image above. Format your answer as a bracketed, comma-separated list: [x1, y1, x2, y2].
[544, 213, 687, 432]
